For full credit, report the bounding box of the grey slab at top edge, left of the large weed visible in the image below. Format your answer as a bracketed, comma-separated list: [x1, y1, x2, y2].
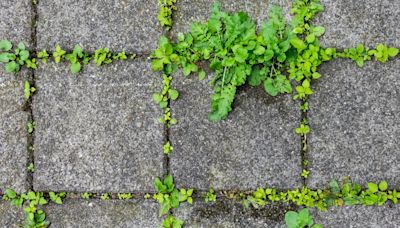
[37, 0, 162, 53]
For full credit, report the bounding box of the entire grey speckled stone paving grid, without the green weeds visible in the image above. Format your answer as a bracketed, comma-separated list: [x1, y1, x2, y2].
[0, 0, 400, 227]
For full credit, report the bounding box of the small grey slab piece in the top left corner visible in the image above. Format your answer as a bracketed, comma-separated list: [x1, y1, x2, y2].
[0, 0, 32, 46]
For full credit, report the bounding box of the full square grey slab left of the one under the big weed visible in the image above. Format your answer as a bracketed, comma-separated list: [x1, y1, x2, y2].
[33, 61, 163, 192]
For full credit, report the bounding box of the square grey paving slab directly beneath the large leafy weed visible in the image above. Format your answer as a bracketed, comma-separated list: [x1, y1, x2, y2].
[170, 72, 301, 190]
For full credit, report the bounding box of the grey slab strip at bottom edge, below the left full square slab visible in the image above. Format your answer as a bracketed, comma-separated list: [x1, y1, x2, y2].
[45, 199, 162, 228]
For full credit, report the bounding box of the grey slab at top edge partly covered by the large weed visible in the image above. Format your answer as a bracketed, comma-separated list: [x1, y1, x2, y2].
[173, 0, 291, 35]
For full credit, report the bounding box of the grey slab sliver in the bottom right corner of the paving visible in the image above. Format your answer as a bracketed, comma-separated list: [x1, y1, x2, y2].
[312, 205, 400, 228]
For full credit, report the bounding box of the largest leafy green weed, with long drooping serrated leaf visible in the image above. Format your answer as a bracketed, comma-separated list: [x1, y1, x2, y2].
[152, 3, 322, 121]
